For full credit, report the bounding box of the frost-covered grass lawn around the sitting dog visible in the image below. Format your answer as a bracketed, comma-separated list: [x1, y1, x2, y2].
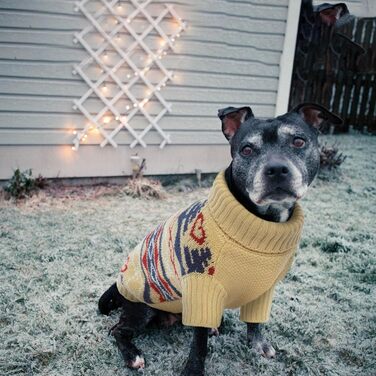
[0, 136, 376, 376]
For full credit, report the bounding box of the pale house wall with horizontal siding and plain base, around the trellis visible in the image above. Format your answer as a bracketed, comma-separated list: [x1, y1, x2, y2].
[0, 0, 289, 179]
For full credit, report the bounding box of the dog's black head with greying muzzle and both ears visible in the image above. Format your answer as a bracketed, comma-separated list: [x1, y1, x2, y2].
[218, 103, 342, 206]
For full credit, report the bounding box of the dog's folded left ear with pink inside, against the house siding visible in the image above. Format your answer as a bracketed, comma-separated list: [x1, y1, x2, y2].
[218, 107, 254, 141]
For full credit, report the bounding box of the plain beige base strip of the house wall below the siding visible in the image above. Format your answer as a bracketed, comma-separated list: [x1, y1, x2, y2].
[0, 145, 234, 179]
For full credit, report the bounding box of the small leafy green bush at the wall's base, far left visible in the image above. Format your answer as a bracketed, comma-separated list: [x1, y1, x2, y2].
[4, 168, 47, 200]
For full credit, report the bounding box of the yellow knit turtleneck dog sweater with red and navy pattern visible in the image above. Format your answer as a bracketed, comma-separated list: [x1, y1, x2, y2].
[117, 172, 303, 328]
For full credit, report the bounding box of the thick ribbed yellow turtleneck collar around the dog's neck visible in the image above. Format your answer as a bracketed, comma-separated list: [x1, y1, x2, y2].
[207, 172, 304, 253]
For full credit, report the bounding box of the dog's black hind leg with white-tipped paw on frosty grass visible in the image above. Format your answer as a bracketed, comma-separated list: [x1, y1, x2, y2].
[111, 299, 157, 369]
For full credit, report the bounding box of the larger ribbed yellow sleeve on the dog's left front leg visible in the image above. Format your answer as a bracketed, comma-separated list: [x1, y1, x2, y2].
[182, 274, 227, 328]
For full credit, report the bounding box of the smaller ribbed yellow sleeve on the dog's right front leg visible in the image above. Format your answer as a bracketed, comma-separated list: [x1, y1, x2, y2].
[240, 286, 274, 323]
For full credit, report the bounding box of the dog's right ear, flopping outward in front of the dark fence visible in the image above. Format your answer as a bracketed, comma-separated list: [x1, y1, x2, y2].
[292, 103, 343, 129]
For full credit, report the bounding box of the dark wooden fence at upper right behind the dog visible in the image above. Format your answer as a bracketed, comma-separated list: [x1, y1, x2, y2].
[289, 3, 376, 133]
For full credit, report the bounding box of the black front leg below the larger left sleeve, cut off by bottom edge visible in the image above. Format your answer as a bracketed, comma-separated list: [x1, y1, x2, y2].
[181, 327, 209, 376]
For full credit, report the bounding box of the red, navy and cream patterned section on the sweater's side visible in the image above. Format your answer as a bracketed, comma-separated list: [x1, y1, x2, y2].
[121, 201, 215, 304]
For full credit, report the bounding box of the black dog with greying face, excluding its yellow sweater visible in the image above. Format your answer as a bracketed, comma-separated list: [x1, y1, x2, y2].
[99, 104, 341, 375]
